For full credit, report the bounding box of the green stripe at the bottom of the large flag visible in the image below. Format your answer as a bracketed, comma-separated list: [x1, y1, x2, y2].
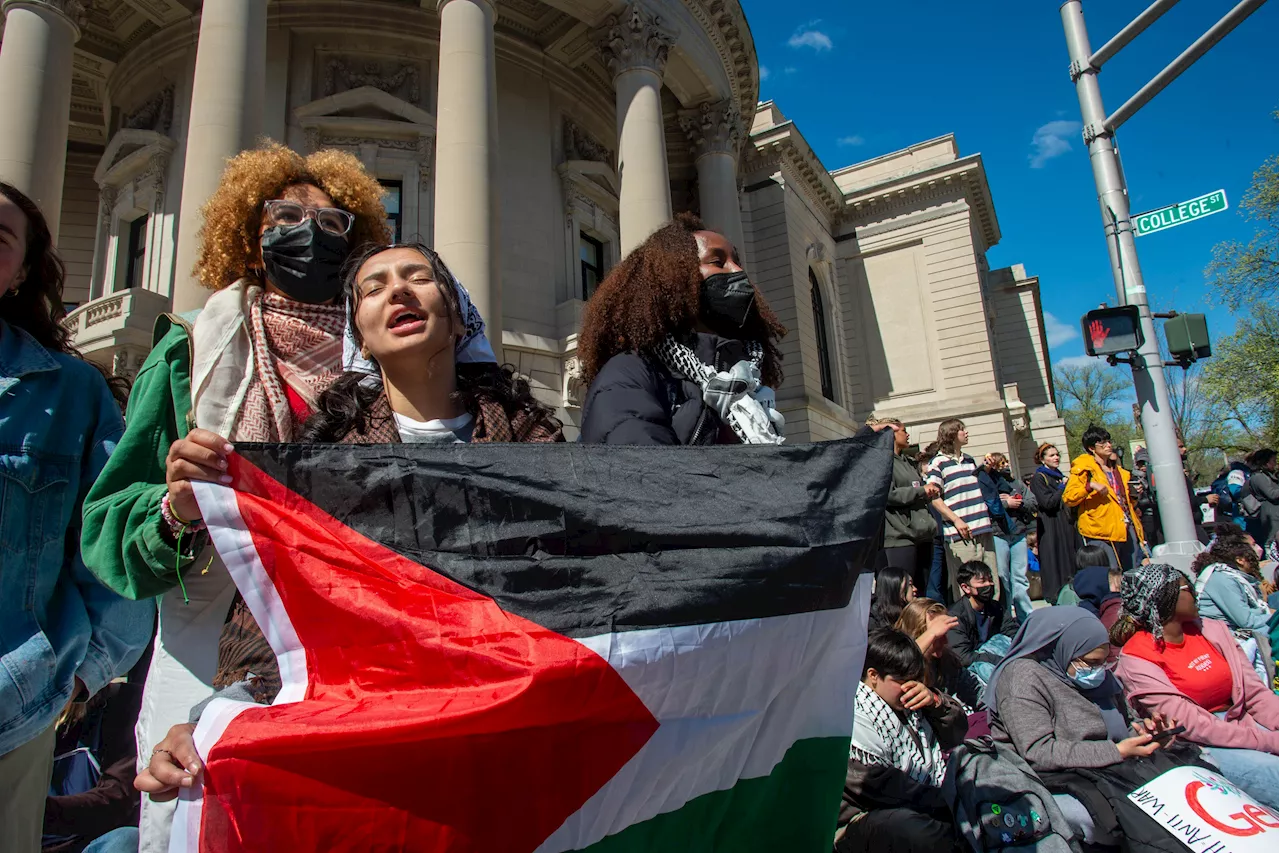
[570, 735, 849, 853]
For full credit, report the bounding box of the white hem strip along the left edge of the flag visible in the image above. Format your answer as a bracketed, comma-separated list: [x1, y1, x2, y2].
[169, 480, 307, 853]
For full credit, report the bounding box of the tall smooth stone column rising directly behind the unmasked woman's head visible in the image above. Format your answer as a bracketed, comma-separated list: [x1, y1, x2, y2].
[434, 0, 502, 345]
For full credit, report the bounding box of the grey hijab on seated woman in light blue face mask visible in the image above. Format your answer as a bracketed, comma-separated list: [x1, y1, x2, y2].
[982, 607, 1129, 740]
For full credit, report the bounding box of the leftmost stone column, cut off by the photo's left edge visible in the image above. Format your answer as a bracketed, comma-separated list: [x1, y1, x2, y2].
[0, 0, 84, 241]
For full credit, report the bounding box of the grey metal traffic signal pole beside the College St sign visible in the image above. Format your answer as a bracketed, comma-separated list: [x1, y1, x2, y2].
[1061, 0, 1266, 567]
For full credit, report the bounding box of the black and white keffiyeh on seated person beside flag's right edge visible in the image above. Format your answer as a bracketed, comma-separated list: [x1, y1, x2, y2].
[849, 683, 947, 788]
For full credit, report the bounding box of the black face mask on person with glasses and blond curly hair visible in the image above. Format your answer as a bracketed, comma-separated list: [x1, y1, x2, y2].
[261, 219, 349, 305]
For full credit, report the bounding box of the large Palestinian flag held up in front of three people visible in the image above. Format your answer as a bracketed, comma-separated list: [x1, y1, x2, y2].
[170, 433, 892, 853]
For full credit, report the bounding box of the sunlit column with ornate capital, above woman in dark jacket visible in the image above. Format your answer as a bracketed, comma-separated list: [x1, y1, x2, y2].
[600, 3, 677, 256]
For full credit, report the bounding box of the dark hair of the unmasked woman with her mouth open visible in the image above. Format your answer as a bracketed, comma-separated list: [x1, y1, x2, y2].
[298, 242, 561, 443]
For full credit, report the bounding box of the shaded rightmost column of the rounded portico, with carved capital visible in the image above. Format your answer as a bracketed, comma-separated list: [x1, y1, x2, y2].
[680, 100, 745, 255]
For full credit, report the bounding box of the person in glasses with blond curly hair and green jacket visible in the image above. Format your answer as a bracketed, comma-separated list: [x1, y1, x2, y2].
[82, 143, 389, 850]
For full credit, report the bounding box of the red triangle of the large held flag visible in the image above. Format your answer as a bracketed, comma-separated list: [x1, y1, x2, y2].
[200, 456, 658, 853]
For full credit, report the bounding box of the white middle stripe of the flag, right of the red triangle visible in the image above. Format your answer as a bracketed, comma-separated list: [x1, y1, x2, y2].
[536, 574, 872, 853]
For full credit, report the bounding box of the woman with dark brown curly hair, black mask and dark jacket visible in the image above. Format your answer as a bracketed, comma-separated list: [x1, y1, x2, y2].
[577, 214, 786, 444]
